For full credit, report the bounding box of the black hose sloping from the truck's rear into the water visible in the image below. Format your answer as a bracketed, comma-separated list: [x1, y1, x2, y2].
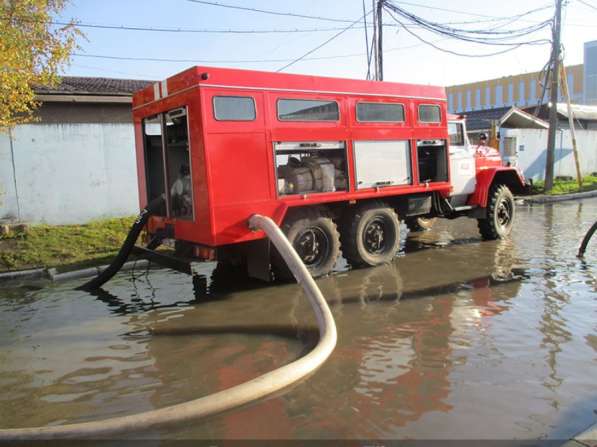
[77, 194, 164, 292]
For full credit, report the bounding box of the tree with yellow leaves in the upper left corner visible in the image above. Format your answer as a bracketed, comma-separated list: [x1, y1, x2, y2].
[0, 0, 81, 131]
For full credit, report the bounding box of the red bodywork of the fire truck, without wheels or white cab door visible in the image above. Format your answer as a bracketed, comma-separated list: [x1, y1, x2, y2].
[133, 67, 523, 278]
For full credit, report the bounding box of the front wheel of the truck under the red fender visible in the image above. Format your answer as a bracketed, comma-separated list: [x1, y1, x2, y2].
[477, 184, 515, 240]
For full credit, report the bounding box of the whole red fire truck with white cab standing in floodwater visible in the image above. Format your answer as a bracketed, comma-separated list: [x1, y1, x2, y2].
[133, 67, 524, 280]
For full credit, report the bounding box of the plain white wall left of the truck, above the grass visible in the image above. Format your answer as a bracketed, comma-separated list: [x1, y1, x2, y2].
[0, 123, 139, 224]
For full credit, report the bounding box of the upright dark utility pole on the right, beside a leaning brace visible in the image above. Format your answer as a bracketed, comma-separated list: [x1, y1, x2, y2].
[545, 0, 562, 192]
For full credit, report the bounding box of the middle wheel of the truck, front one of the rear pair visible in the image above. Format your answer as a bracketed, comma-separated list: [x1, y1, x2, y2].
[340, 202, 400, 267]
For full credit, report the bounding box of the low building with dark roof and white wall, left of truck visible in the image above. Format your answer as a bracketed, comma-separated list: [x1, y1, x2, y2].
[0, 76, 149, 224]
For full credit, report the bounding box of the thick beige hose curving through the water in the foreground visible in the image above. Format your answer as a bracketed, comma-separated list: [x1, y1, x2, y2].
[0, 215, 337, 442]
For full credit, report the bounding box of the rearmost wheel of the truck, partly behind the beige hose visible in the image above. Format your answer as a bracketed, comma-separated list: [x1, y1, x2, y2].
[272, 209, 340, 280]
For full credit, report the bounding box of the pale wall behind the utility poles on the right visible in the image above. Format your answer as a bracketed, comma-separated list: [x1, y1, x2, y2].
[500, 129, 597, 180]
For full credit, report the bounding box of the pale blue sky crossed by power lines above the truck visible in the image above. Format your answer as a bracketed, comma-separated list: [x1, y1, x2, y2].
[58, 0, 597, 86]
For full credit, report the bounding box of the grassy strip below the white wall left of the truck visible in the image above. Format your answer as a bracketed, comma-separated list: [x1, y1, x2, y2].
[0, 217, 135, 272]
